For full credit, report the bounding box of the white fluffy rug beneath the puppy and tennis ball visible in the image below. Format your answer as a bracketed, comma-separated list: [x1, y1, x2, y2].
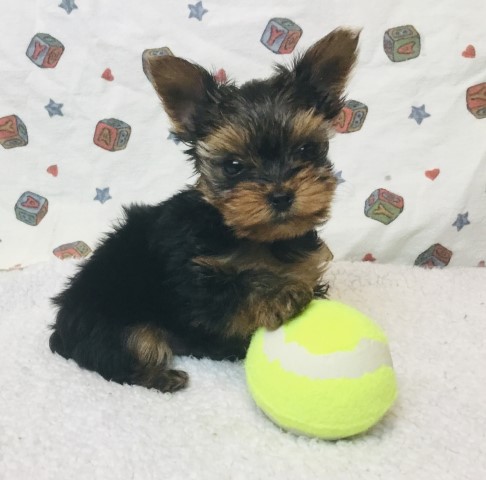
[0, 262, 486, 480]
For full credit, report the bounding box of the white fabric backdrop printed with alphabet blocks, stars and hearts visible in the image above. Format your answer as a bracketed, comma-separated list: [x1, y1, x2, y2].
[0, 0, 486, 269]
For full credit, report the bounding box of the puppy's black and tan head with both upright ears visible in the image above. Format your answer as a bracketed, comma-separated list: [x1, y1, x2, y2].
[144, 29, 358, 242]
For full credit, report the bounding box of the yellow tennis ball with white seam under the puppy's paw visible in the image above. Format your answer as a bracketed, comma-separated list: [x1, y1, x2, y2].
[245, 300, 397, 440]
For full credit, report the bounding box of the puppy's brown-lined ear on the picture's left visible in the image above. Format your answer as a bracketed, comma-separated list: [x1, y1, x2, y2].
[147, 55, 218, 142]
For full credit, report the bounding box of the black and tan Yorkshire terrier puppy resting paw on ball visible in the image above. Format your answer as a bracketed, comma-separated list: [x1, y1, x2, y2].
[50, 29, 358, 392]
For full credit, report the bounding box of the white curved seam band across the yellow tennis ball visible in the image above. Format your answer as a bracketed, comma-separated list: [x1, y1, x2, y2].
[263, 328, 393, 380]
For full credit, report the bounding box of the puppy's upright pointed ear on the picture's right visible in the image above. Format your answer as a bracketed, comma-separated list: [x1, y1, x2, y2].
[286, 28, 359, 119]
